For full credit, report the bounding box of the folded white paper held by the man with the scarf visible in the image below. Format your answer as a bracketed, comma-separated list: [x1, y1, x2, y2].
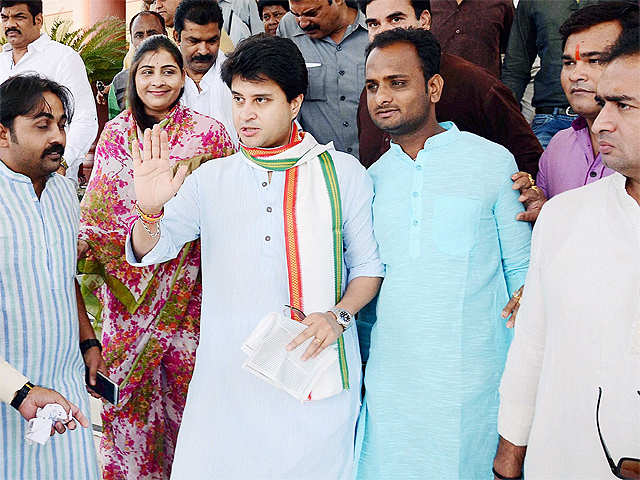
[242, 312, 342, 401]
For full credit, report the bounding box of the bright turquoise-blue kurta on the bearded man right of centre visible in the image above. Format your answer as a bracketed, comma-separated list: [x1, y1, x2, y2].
[358, 122, 531, 480]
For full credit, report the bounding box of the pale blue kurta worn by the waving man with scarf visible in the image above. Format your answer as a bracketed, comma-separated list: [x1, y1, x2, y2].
[127, 150, 383, 480]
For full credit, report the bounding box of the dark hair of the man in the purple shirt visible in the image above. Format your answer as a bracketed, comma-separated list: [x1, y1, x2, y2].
[560, 1, 638, 49]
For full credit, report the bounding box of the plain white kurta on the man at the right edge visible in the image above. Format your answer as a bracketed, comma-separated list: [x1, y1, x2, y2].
[498, 173, 640, 480]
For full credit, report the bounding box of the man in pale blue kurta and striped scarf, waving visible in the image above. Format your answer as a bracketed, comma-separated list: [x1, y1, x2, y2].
[127, 35, 383, 480]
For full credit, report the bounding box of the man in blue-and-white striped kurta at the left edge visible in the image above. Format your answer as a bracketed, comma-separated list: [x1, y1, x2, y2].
[0, 76, 99, 480]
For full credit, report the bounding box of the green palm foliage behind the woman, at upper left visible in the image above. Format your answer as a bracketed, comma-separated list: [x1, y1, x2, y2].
[0, 17, 127, 84]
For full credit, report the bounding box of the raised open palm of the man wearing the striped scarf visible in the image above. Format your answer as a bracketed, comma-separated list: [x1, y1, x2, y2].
[131, 124, 187, 214]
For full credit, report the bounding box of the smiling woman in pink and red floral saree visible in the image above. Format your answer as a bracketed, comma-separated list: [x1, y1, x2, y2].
[79, 35, 233, 480]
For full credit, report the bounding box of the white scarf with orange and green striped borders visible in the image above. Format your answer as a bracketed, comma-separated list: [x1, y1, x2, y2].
[240, 123, 349, 400]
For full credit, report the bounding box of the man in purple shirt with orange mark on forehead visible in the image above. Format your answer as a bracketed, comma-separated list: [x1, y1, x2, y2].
[513, 2, 638, 221]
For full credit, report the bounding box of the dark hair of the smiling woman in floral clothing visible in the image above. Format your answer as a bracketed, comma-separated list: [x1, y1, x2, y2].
[127, 35, 184, 130]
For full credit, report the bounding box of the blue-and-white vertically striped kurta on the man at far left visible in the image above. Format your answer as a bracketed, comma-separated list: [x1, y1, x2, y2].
[0, 161, 98, 480]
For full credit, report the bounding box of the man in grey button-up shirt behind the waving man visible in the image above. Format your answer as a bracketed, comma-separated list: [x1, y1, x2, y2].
[276, 0, 369, 156]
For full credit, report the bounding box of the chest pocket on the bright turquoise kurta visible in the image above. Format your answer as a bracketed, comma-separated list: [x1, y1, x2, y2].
[431, 195, 481, 256]
